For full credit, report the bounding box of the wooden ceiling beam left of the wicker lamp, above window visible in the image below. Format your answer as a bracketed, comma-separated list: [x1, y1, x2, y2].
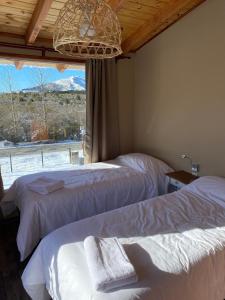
[25, 0, 53, 44]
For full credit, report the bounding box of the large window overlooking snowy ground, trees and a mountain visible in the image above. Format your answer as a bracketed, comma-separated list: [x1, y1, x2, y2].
[0, 65, 86, 188]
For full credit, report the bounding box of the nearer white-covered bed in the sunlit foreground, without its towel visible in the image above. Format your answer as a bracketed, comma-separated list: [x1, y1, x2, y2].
[22, 177, 225, 300]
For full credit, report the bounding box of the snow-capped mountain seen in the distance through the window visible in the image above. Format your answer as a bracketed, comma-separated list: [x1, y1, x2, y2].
[22, 76, 85, 93]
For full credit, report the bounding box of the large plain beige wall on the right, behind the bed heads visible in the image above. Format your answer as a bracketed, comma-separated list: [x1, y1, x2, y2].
[133, 0, 225, 176]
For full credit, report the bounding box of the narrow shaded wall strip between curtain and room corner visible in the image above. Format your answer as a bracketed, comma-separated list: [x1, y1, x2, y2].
[117, 59, 134, 154]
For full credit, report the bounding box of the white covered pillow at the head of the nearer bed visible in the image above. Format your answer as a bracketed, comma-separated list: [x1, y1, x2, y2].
[183, 176, 225, 204]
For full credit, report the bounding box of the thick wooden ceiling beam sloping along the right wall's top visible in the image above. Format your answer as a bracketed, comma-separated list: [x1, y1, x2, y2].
[122, 0, 206, 53]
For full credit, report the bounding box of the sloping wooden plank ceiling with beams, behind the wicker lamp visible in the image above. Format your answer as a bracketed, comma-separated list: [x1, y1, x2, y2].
[0, 0, 205, 60]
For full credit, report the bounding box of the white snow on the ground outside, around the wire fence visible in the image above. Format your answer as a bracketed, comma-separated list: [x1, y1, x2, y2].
[0, 150, 83, 189]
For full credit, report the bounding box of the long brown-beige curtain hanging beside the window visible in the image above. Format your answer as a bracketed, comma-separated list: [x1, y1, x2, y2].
[85, 59, 119, 162]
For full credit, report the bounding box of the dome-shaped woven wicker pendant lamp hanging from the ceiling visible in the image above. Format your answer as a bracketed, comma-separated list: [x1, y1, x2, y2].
[53, 0, 122, 59]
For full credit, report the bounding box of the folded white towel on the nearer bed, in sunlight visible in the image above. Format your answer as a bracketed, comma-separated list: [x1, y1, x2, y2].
[84, 236, 137, 292]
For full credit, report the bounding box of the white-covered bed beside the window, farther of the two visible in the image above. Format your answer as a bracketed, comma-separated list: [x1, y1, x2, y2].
[1, 154, 171, 260]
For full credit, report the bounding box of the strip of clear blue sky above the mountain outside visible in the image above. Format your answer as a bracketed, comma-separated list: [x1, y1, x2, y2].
[0, 64, 85, 93]
